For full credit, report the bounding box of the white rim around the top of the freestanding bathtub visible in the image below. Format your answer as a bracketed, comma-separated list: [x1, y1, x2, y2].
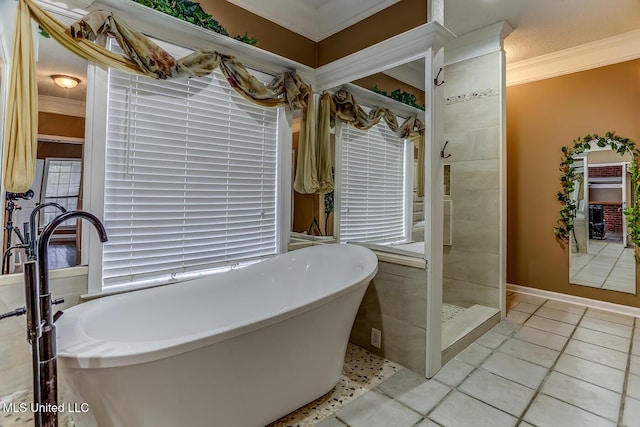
[58, 244, 378, 369]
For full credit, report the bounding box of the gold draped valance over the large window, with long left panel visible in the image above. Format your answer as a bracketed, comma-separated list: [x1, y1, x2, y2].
[3, 0, 317, 192]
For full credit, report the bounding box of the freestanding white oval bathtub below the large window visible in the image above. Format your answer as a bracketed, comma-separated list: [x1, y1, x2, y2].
[57, 244, 378, 427]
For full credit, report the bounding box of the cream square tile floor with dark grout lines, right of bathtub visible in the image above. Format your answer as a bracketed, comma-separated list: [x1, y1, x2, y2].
[317, 293, 640, 427]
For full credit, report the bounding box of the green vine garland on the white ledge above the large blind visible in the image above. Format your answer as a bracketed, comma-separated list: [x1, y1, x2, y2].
[133, 0, 258, 45]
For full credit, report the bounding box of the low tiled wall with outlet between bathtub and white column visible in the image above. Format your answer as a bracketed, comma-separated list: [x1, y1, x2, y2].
[349, 261, 427, 374]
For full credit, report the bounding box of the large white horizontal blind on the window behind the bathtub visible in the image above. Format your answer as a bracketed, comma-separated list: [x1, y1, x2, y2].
[103, 69, 278, 289]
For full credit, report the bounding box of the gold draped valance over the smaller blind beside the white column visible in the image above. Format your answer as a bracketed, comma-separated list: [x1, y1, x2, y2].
[316, 89, 425, 197]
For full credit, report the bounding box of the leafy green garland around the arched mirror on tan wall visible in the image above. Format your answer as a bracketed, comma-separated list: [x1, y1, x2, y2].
[553, 132, 640, 260]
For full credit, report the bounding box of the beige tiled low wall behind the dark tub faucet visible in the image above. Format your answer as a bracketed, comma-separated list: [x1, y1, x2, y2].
[0, 272, 87, 397]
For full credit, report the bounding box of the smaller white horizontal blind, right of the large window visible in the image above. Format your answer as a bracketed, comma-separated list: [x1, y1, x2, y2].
[337, 120, 406, 243]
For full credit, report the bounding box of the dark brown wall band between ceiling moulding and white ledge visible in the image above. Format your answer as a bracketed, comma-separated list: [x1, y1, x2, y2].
[200, 0, 427, 68]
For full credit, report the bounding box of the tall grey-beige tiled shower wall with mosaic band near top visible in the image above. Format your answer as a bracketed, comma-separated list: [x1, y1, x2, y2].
[443, 52, 503, 308]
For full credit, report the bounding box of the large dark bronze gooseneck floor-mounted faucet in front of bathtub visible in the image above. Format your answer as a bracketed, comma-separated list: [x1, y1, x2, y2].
[33, 211, 107, 427]
